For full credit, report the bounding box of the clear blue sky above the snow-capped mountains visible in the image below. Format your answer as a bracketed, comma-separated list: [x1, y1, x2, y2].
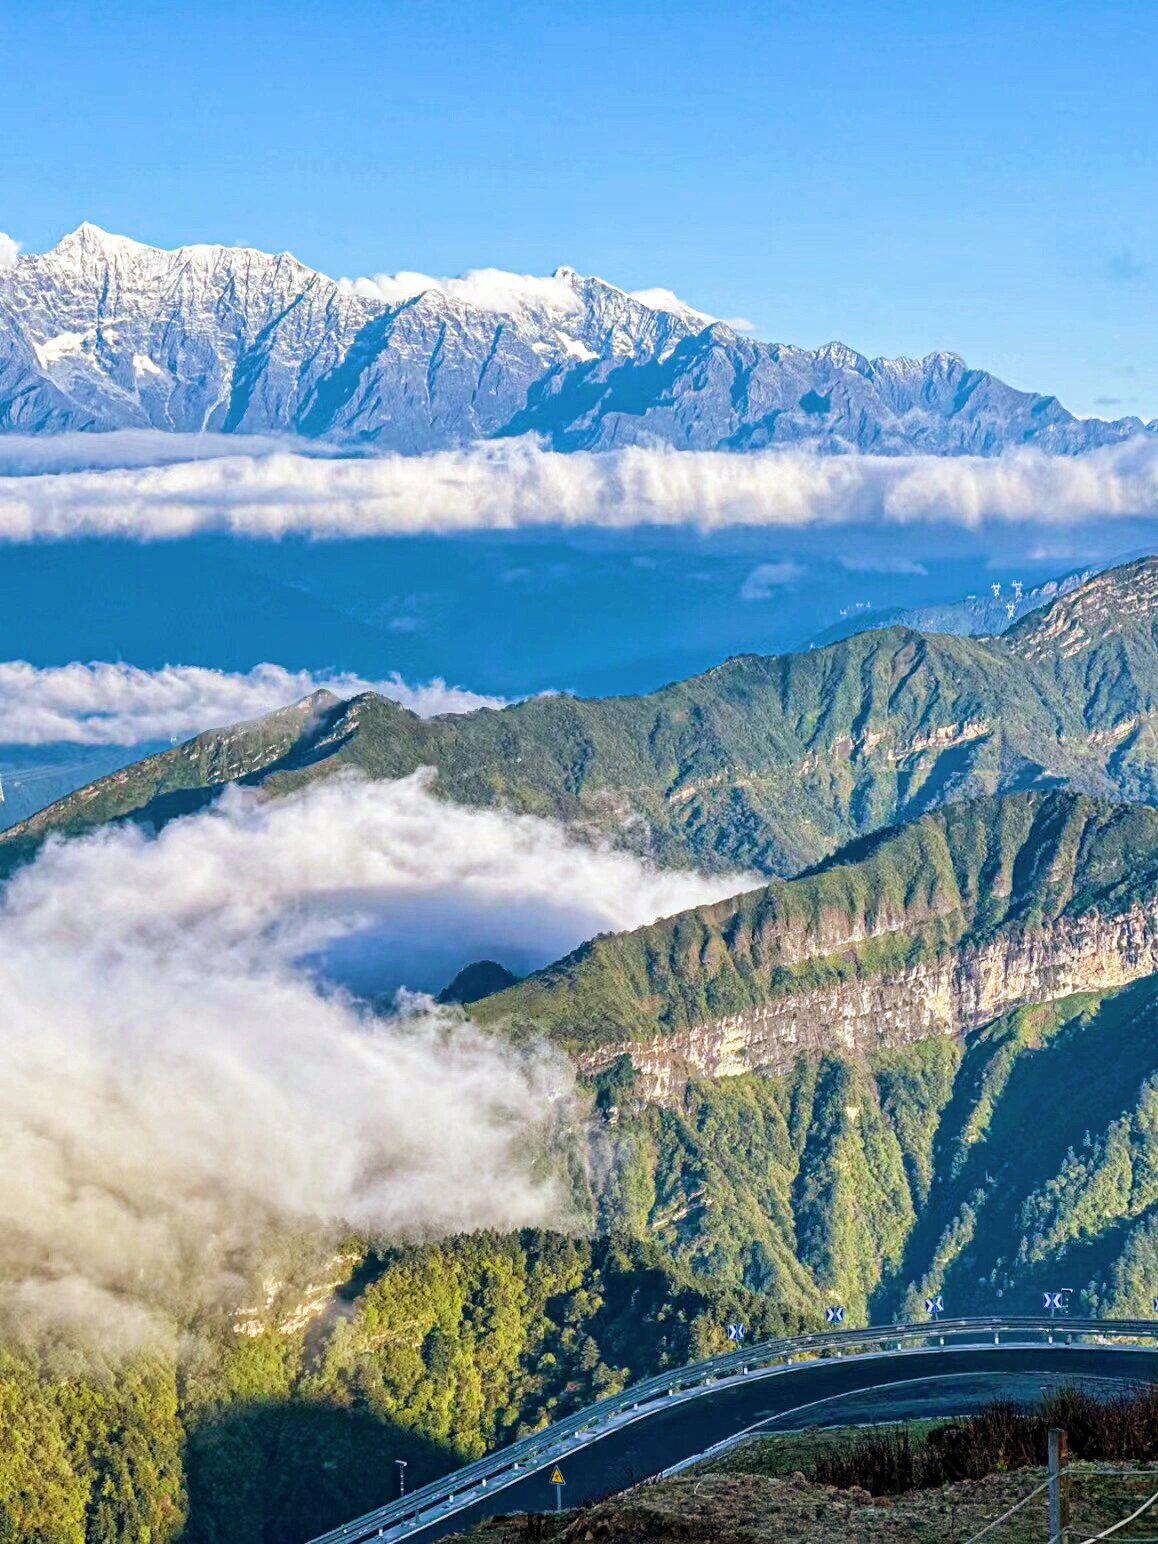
[0, 0, 1158, 417]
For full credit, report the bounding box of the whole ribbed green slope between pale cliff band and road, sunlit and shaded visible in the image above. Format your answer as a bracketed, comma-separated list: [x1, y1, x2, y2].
[599, 976, 1158, 1322]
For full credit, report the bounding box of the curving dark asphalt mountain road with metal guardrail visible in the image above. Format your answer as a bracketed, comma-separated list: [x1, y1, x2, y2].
[305, 1320, 1158, 1544]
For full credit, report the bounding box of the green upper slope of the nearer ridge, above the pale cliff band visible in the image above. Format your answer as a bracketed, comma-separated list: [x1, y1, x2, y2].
[472, 792, 1158, 1051]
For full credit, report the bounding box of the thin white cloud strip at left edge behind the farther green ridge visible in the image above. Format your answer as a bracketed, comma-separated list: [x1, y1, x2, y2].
[0, 659, 505, 746]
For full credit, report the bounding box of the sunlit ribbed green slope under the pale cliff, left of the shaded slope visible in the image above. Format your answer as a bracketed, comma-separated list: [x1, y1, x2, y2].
[599, 1039, 960, 1322]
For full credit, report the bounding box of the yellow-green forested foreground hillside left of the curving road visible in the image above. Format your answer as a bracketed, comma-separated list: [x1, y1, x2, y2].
[0, 1232, 797, 1544]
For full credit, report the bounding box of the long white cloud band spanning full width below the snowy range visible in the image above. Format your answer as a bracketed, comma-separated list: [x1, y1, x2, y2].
[0, 435, 1158, 540]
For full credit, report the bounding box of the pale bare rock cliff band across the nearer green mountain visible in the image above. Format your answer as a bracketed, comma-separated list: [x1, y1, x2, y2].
[579, 905, 1158, 1099]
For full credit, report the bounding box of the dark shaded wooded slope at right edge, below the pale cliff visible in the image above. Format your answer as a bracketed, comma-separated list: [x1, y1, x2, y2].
[880, 977, 1158, 1315]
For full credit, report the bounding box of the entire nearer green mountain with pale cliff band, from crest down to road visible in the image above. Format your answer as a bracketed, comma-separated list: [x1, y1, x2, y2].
[546, 794, 1158, 1319]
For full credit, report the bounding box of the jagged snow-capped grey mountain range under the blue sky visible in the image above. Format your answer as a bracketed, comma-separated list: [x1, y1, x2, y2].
[0, 224, 1158, 455]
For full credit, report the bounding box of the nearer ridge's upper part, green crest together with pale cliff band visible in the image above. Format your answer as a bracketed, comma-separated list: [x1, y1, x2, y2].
[474, 792, 1158, 1068]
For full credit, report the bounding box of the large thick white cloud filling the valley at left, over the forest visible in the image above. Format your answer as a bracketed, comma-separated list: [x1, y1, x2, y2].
[0, 775, 744, 1336]
